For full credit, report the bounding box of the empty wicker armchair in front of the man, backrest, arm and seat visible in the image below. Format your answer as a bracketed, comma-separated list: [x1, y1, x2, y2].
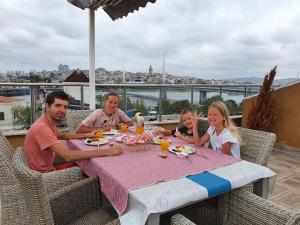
[9, 148, 119, 225]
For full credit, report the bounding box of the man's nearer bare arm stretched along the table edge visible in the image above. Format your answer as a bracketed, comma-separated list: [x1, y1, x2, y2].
[49, 144, 122, 162]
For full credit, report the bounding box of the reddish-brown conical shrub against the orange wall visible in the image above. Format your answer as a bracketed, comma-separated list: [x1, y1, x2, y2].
[247, 66, 277, 131]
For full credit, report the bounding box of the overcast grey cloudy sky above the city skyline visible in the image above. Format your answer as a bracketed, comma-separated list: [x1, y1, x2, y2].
[0, 0, 300, 79]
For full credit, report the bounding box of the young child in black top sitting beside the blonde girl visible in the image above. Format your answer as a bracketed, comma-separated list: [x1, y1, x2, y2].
[172, 108, 194, 143]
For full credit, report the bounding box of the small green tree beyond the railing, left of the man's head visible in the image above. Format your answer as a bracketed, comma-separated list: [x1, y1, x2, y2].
[11, 105, 31, 129]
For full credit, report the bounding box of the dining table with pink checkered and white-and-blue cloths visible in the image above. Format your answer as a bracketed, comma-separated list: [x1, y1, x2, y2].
[67, 132, 276, 225]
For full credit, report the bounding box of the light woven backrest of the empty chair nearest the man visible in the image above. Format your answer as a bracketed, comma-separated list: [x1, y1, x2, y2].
[13, 151, 54, 225]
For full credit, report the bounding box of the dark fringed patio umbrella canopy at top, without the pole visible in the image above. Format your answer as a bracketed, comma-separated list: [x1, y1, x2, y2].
[68, 0, 156, 20]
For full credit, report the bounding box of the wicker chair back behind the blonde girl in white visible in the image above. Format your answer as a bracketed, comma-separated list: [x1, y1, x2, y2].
[237, 127, 276, 166]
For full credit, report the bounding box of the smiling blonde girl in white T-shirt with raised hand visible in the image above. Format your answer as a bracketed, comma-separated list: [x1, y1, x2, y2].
[192, 101, 240, 158]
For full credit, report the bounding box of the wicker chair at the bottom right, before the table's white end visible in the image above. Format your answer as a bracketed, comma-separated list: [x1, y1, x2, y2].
[171, 189, 300, 225]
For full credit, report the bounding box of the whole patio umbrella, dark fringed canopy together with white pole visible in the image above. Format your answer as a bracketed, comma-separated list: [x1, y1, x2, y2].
[68, 0, 156, 110]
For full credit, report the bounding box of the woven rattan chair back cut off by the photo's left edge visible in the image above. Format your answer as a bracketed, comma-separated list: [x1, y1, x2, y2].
[0, 133, 30, 225]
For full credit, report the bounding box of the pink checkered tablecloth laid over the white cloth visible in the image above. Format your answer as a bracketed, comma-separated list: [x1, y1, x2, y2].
[68, 137, 239, 215]
